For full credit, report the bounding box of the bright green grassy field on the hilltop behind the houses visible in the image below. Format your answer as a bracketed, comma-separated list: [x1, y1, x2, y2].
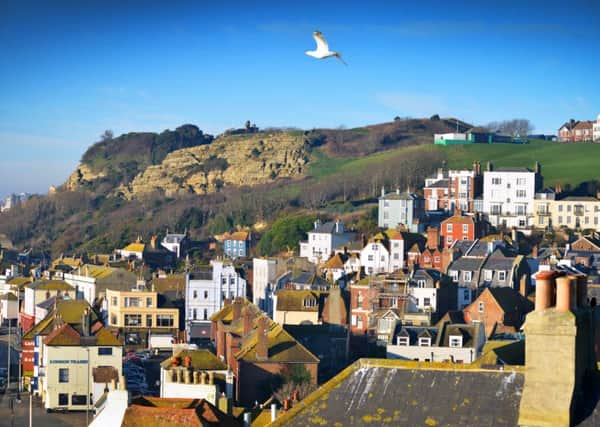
[309, 140, 600, 186]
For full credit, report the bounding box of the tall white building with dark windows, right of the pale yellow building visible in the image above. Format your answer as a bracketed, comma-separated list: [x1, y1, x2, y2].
[185, 260, 246, 339]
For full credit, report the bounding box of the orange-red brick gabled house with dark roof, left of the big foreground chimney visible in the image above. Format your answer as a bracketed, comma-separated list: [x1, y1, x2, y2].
[463, 287, 533, 337]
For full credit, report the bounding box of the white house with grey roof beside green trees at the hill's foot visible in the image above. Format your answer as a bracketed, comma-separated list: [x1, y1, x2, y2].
[300, 220, 354, 264]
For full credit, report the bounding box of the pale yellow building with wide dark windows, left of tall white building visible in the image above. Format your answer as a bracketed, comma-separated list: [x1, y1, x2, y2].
[106, 289, 179, 347]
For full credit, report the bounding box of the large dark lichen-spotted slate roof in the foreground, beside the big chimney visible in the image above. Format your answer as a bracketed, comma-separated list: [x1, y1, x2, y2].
[272, 359, 524, 426]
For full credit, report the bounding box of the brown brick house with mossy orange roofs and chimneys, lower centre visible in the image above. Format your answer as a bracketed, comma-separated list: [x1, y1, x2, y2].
[210, 298, 319, 405]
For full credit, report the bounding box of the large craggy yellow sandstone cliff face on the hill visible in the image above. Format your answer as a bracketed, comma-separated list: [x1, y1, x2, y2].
[117, 133, 309, 198]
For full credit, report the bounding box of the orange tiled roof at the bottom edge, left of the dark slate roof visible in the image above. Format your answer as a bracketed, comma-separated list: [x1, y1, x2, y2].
[121, 396, 240, 427]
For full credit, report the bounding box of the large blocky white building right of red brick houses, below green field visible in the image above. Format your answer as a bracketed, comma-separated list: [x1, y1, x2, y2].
[483, 168, 536, 228]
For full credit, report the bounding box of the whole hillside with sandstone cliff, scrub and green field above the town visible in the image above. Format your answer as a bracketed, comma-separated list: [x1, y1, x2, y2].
[0, 120, 600, 254]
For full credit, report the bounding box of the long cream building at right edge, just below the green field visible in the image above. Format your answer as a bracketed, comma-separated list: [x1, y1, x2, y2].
[533, 197, 600, 231]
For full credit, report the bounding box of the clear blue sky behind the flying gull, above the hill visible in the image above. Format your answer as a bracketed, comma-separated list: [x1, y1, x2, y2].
[0, 0, 600, 196]
